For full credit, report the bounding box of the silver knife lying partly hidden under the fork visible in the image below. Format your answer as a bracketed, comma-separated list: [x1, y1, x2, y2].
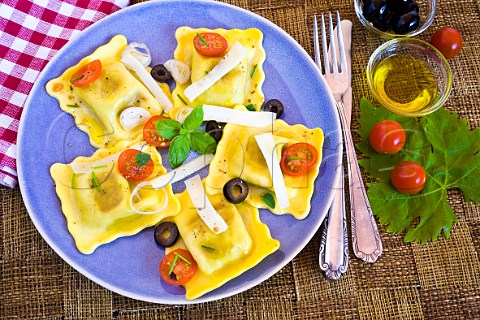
[319, 20, 352, 280]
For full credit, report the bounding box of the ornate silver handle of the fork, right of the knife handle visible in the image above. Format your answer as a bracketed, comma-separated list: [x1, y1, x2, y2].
[337, 101, 383, 262]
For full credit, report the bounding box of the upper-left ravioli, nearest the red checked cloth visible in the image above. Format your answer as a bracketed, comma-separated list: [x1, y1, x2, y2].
[46, 35, 170, 148]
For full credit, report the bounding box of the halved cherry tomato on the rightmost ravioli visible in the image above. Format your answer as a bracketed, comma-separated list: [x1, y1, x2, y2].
[280, 142, 318, 177]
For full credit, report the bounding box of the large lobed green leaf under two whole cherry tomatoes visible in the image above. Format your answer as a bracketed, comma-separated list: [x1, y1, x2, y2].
[357, 99, 480, 243]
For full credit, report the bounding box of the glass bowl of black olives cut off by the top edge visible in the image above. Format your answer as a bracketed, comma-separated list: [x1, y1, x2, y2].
[355, 0, 437, 39]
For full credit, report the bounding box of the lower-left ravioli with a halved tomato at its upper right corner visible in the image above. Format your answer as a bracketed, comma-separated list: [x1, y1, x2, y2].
[50, 142, 180, 254]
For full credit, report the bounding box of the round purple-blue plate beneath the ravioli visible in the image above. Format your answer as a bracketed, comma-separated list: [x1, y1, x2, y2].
[17, 1, 341, 304]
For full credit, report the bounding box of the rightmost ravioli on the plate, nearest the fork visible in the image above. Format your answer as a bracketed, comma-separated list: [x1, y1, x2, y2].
[205, 108, 324, 219]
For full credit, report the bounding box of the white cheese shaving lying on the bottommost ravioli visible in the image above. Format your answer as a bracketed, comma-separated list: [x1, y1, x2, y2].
[185, 175, 228, 234]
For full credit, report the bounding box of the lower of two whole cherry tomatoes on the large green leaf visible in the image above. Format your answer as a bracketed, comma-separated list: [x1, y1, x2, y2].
[390, 161, 427, 194]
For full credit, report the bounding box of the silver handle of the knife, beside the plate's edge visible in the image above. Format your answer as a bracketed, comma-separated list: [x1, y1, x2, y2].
[319, 161, 348, 280]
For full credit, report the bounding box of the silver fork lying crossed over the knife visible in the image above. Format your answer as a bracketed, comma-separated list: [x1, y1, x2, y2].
[314, 11, 383, 262]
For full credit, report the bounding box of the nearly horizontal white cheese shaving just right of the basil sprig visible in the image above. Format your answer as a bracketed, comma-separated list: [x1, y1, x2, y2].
[203, 104, 277, 127]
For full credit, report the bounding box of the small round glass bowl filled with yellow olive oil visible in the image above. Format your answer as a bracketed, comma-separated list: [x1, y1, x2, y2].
[367, 38, 452, 117]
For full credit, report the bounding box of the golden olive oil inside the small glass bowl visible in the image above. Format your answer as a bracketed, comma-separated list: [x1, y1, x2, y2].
[373, 54, 437, 113]
